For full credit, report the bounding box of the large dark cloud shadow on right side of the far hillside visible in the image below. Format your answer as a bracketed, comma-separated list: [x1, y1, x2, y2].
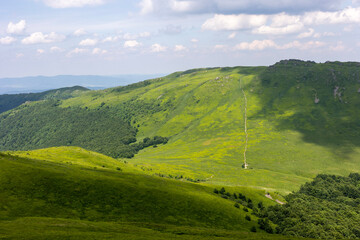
[248, 60, 360, 157]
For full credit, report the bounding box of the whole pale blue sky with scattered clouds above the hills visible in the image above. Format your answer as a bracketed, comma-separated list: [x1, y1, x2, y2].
[0, 0, 360, 77]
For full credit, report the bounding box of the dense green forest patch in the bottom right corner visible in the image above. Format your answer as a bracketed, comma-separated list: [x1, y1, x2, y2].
[267, 173, 360, 239]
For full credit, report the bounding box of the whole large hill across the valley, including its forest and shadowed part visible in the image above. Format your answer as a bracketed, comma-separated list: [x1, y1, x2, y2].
[0, 60, 360, 194]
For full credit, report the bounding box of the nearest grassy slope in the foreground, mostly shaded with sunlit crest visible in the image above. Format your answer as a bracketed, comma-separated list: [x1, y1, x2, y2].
[0, 147, 298, 239]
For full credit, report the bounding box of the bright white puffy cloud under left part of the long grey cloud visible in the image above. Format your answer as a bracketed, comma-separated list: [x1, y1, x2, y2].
[202, 14, 267, 31]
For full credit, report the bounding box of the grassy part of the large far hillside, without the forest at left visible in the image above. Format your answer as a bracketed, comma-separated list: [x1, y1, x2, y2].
[62, 63, 360, 193]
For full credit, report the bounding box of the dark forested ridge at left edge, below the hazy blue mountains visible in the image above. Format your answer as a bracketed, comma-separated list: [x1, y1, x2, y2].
[0, 86, 89, 113]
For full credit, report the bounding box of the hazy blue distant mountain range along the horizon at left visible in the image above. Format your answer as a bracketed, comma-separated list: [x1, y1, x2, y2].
[0, 74, 163, 94]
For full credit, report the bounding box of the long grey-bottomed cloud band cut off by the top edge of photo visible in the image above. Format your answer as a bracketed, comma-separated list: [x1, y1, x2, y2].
[139, 0, 342, 15]
